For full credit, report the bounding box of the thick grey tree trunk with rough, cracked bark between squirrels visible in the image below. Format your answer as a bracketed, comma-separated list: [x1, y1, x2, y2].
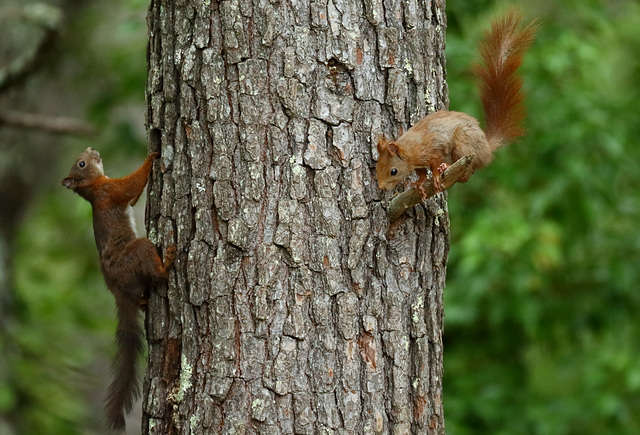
[143, 0, 449, 435]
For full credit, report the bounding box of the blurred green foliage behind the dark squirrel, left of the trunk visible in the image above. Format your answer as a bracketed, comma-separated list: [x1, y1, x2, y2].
[0, 0, 147, 435]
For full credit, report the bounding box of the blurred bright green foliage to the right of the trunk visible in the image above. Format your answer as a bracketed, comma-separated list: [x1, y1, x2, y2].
[444, 0, 640, 435]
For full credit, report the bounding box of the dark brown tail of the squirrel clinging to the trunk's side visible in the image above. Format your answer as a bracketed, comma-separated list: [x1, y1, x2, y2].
[105, 297, 144, 431]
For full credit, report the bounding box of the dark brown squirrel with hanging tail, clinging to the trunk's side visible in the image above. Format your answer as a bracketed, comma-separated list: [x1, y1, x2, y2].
[62, 148, 175, 430]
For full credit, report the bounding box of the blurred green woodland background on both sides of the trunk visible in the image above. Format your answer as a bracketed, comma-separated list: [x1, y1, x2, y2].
[0, 0, 640, 435]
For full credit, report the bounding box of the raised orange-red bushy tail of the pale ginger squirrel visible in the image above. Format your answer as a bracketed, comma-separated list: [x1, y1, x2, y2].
[474, 10, 538, 149]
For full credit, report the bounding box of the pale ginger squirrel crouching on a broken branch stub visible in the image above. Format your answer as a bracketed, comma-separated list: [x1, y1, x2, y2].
[376, 11, 537, 197]
